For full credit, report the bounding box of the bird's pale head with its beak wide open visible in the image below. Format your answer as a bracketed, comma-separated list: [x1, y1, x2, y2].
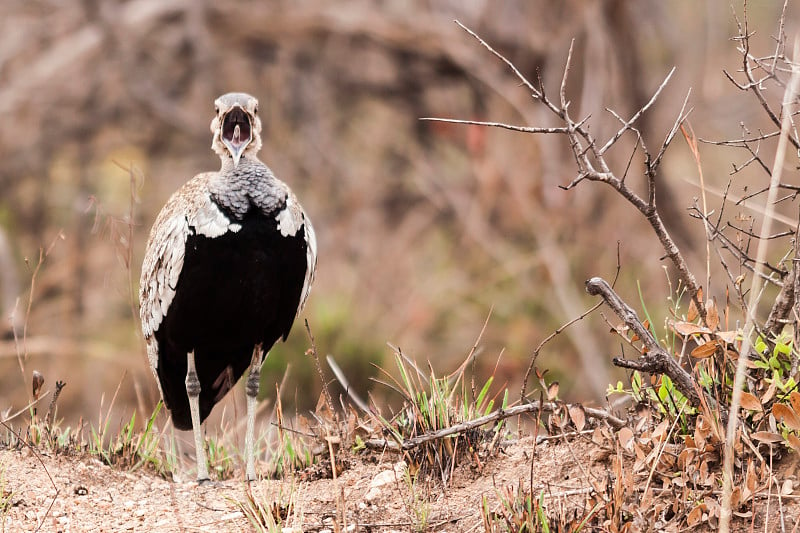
[211, 93, 261, 167]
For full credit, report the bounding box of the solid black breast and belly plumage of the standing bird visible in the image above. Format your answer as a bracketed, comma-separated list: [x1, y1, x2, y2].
[155, 204, 307, 429]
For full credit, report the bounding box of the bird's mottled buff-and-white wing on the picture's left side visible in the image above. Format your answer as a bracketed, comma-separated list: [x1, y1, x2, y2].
[139, 173, 241, 369]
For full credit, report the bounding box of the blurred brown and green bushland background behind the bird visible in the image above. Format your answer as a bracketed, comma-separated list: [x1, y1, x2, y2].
[0, 0, 798, 423]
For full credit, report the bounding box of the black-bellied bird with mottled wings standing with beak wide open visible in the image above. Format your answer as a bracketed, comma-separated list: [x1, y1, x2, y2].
[139, 92, 317, 483]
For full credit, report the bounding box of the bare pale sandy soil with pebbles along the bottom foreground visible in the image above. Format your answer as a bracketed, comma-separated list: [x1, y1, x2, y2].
[0, 438, 798, 532]
